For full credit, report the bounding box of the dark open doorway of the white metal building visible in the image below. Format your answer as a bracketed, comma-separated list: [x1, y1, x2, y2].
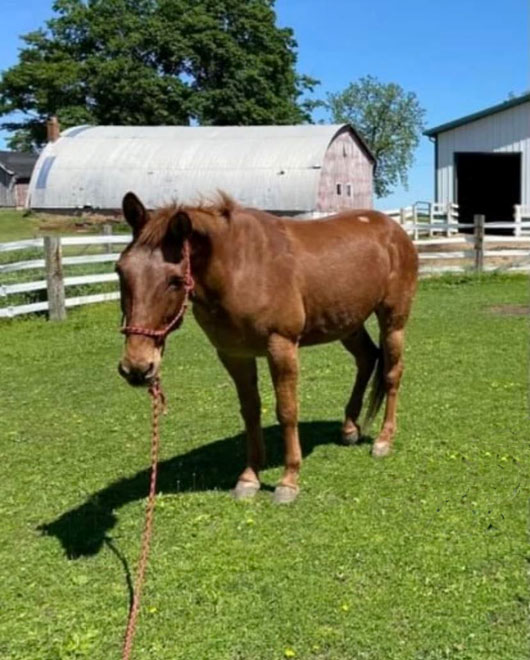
[455, 153, 521, 234]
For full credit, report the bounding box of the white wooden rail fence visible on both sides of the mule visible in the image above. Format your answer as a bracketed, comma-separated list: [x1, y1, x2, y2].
[0, 214, 530, 320]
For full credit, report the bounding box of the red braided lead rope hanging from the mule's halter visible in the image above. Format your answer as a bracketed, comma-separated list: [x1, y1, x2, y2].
[122, 379, 165, 660]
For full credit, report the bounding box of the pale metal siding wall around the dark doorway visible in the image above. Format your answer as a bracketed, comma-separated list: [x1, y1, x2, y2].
[436, 102, 530, 205]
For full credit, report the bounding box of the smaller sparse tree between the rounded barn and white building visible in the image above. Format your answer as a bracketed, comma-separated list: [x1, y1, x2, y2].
[327, 76, 425, 197]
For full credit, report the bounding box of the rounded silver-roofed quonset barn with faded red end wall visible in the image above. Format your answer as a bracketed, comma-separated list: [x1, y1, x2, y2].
[27, 124, 375, 217]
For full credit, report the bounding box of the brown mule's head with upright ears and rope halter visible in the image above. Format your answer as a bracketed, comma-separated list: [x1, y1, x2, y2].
[116, 193, 191, 385]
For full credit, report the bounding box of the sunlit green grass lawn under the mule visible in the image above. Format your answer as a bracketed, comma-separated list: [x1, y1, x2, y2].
[0, 276, 530, 660]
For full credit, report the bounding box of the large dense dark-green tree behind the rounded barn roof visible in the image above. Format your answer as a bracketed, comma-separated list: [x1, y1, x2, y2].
[0, 0, 318, 148]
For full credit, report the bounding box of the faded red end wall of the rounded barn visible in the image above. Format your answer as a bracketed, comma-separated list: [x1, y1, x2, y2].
[317, 129, 373, 212]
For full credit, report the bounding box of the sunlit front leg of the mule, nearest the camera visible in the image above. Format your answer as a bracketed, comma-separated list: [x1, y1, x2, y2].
[267, 335, 302, 504]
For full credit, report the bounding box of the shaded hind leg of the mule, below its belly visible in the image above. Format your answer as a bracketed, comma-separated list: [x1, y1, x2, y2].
[342, 326, 380, 445]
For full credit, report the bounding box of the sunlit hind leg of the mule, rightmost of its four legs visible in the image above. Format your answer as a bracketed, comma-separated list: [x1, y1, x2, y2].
[372, 312, 406, 456]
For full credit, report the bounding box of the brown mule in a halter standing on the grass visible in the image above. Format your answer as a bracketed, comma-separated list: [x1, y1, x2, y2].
[117, 193, 418, 502]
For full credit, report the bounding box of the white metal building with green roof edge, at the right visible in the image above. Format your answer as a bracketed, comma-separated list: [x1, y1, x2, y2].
[425, 94, 530, 228]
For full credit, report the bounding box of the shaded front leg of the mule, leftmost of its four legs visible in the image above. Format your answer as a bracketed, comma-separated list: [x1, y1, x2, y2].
[218, 351, 265, 499]
